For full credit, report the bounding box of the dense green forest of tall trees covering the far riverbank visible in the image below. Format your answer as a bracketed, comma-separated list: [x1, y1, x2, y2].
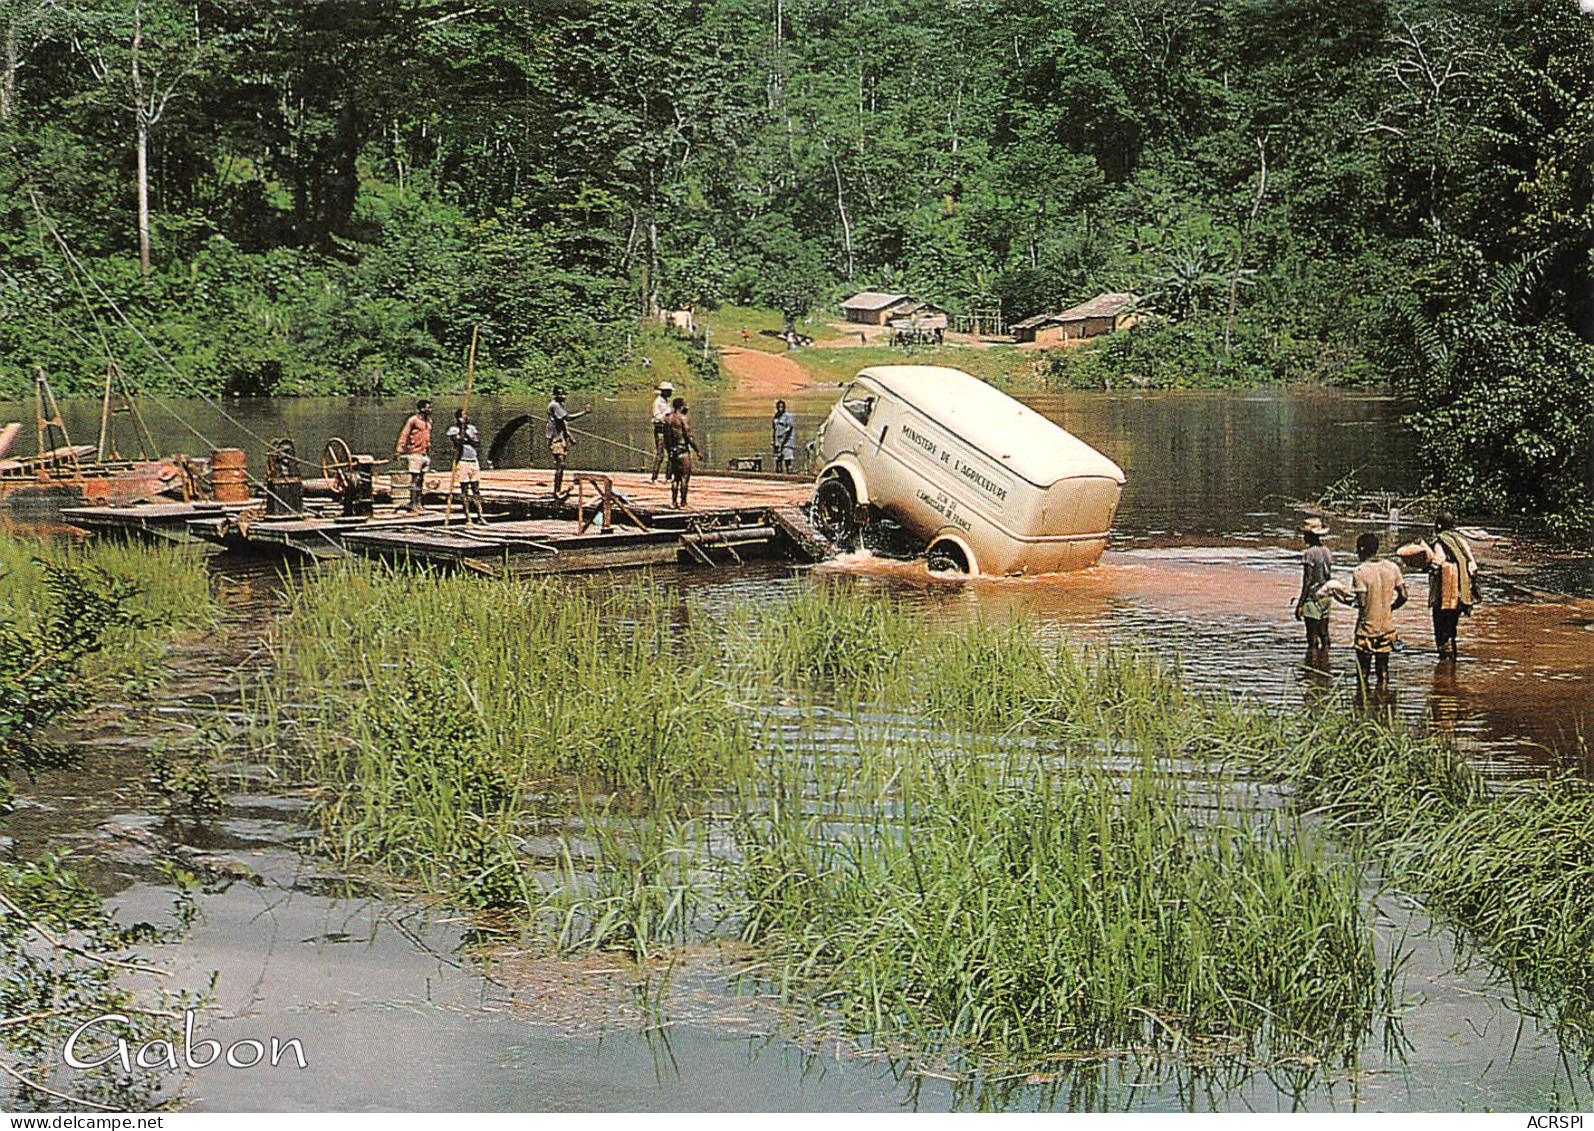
[0, 0, 1594, 532]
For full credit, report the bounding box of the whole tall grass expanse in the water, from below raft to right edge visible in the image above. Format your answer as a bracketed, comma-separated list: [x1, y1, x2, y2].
[261, 564, 1594, 1058]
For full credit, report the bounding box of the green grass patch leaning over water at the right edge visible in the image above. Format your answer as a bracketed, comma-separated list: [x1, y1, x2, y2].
[1207, 704, 1594, 1040]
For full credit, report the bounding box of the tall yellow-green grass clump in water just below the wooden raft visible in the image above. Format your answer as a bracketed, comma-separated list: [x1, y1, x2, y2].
[260, 564, 752, 908]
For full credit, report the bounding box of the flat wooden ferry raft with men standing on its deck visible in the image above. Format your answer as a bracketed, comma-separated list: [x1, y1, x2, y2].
[172, 470, 830, 573]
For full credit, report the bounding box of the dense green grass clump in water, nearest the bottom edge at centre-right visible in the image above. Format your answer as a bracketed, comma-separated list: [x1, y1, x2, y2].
[733, 739, 1392, 1064]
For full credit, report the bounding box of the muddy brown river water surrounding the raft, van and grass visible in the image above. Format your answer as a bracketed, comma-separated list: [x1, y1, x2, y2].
[0, 389, 1594, 1110]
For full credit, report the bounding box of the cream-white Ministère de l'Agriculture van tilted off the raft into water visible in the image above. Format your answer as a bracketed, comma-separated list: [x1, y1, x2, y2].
[813, 365, 1124, 577]
